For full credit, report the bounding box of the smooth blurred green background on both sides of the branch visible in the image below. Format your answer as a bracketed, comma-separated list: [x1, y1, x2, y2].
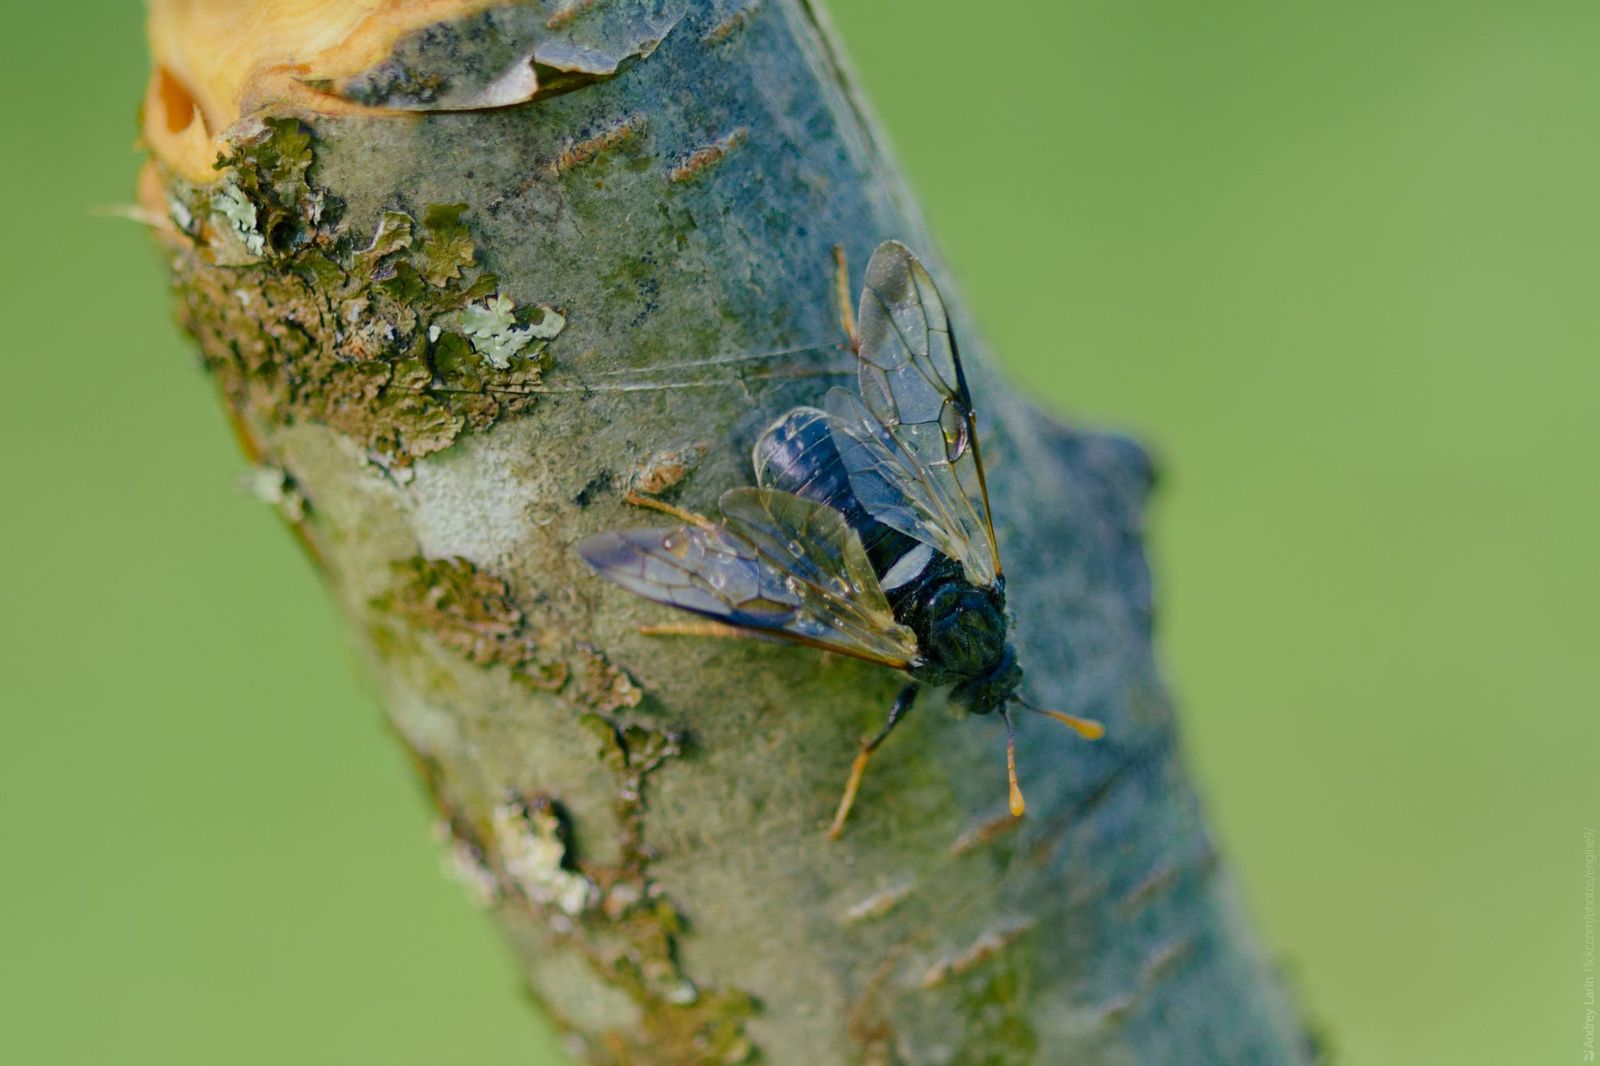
[0, 0, 1600, 1066]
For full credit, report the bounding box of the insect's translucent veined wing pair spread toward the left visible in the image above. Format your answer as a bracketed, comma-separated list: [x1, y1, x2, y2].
[578, 488, 917, 669]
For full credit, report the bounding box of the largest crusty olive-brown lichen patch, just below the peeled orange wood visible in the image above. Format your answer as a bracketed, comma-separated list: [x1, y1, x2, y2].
[162, 118, 565, 460]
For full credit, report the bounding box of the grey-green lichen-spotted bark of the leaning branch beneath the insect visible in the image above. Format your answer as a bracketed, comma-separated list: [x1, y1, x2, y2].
[144, 0, 1310, 1064]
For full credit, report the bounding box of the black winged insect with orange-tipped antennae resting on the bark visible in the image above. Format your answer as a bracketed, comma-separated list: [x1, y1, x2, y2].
[578, 242, 1102, 837]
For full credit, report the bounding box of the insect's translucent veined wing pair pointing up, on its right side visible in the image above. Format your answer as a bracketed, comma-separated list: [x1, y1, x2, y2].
[827, 240, 1000, 586]
